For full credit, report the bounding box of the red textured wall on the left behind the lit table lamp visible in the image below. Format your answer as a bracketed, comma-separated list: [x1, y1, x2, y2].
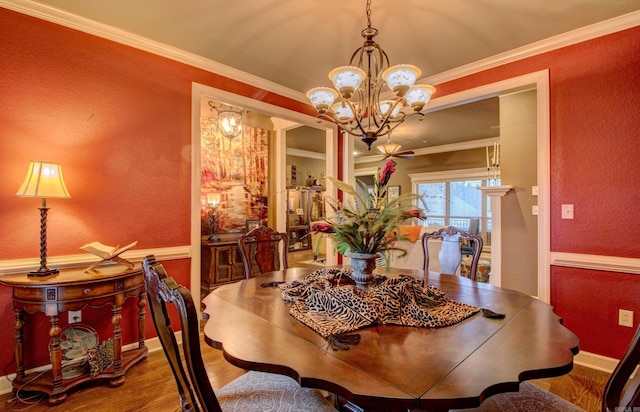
[0, 8, 313, 372]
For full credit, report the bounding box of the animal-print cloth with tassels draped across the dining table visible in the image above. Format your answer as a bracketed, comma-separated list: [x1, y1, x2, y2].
[280, 269, 480, 338]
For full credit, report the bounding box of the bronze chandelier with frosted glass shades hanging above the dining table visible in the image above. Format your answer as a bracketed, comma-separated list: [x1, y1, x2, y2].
[307, 0, 435, 150]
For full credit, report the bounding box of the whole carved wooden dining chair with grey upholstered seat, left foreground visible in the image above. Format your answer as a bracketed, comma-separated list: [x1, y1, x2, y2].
[142, 255, 336, 412]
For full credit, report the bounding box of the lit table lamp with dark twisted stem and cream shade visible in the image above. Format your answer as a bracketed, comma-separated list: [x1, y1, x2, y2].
[16, 161, 71, 276]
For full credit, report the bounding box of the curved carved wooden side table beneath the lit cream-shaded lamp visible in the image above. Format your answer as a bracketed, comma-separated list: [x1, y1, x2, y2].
[0, 265, 148, 404]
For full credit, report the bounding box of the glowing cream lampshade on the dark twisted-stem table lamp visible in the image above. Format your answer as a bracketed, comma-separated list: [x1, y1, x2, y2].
[16, 161, 71, 199]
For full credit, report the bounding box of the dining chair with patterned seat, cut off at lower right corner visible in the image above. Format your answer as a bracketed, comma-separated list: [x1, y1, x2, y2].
[450, 325, 640, 412]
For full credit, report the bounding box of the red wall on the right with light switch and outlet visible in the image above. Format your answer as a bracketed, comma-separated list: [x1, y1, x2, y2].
[438, 27, 640, 359]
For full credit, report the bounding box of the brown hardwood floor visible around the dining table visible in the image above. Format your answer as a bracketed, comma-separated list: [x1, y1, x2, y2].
[0, 343, 609, 412]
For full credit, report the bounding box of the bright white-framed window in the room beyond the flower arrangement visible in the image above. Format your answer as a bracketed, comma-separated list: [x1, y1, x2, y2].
[411, 170, 500, 246]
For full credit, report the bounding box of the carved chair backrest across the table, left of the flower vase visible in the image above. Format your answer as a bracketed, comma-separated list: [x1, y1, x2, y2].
[238, 225, 289, 279]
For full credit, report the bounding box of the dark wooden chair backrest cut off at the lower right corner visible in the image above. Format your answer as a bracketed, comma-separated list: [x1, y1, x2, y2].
[602, 325, 640, 412]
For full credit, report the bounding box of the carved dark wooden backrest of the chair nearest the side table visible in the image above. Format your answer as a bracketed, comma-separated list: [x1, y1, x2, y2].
[142, 256, 221, 412]
